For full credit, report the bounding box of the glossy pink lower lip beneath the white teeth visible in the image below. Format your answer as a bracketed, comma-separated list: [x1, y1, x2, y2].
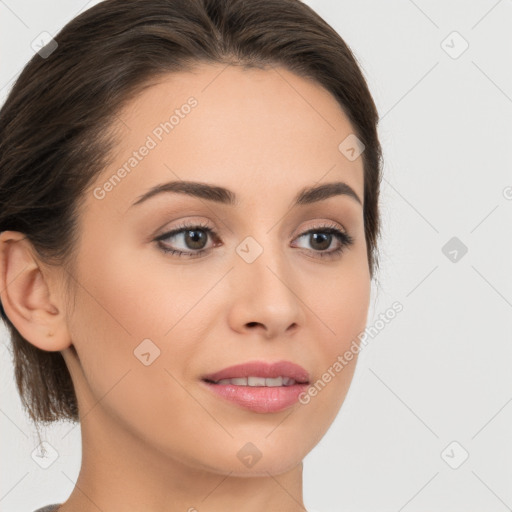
[201, 380, 309, 412]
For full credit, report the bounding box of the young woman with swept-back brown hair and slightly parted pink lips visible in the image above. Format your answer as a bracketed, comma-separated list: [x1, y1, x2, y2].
[0, 0, 381, 512]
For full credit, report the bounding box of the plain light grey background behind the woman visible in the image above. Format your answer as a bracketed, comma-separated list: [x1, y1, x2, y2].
[0, 0, 512, 512]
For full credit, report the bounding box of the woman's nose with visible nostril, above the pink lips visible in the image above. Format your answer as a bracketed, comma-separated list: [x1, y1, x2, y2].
[228, 240, 305, 339]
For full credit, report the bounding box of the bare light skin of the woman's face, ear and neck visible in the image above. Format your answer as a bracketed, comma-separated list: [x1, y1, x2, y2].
[0, 64, 371, 512]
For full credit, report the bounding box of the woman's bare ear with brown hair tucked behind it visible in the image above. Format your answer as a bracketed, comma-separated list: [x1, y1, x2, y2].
[0, 231, 71, 351]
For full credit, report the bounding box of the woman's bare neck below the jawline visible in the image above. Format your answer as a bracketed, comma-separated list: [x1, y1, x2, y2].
[59, 404, 306, 512]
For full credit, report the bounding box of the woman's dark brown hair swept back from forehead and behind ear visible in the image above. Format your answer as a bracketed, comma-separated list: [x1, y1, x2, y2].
[0, 0, 382, 423]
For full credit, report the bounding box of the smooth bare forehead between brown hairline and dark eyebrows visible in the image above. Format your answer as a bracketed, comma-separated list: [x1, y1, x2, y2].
[87, 64, 364, 212]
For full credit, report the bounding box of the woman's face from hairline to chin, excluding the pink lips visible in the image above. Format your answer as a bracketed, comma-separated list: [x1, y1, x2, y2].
[64, 65, 370, 475]
